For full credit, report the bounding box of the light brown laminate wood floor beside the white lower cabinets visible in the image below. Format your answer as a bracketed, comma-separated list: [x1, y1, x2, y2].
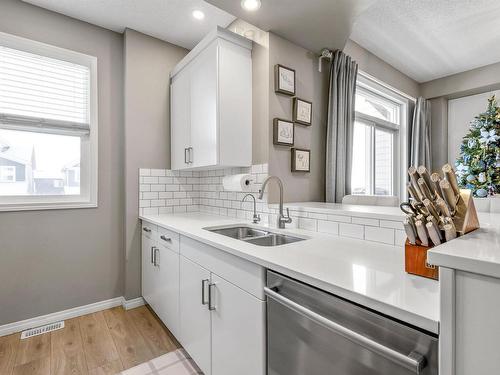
[0, 306, 181, 375]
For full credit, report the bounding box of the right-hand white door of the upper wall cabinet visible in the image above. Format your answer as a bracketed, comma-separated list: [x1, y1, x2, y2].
[190, 41, 218, 167]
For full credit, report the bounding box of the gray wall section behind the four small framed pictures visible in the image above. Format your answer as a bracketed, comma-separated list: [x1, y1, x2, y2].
[268, 33, 328, 202]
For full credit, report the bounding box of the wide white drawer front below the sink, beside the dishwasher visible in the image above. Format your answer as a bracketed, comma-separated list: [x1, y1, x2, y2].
[180, 236, 265, 300]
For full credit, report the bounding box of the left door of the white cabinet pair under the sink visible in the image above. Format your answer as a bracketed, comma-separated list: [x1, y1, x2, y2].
[179, 256, 211, 375]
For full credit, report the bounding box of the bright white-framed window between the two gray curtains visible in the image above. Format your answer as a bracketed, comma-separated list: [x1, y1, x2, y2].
[351, 74, 408, 197]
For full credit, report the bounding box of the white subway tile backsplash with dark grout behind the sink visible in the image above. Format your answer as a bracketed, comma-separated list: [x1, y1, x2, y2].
[139, 164, 406, 246]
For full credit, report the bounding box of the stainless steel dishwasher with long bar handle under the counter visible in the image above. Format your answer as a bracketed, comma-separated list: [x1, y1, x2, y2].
[265, 271, 438, 375]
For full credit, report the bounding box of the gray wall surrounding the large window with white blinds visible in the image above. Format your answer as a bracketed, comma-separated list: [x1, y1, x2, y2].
[0, 0, 124, 325]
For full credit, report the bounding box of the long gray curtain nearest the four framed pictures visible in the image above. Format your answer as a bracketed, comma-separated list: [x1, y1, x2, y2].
[325, 51, 358, 203]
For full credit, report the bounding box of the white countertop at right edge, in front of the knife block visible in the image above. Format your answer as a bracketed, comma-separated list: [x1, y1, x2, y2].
[428, 213, 500, 278]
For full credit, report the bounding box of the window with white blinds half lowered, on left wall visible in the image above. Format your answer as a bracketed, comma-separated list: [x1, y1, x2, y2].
[0, 33, 97, 210]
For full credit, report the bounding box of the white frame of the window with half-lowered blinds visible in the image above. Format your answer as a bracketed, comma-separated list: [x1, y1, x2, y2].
[0, 32, 98, 211]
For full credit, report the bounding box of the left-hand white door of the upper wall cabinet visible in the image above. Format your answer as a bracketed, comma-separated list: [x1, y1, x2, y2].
[170, 67, 191, 169]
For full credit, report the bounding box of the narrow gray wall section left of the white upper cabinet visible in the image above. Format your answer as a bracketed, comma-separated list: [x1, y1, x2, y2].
[124, 29, 188, 299]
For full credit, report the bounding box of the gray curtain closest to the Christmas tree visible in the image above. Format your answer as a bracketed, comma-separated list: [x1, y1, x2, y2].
[409, 97, 431, 171]
